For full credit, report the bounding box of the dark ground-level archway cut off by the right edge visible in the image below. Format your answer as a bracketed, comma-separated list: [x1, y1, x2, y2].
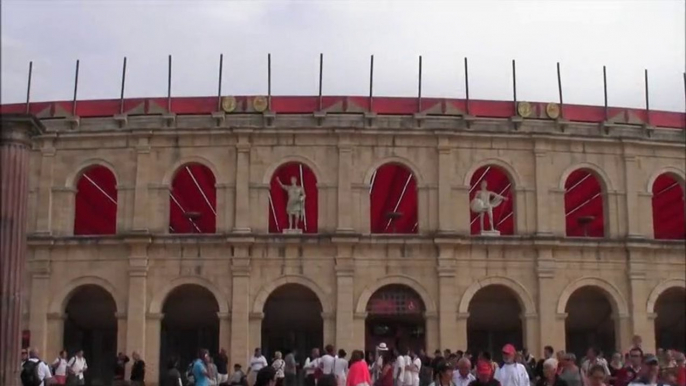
[655, 287, 686, 352]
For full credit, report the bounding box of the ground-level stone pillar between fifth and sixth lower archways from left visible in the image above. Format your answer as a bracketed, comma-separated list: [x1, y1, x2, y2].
[527, 248, 565, 357]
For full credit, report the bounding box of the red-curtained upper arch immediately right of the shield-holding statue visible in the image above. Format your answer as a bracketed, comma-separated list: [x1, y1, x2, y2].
[565, 169, 605, 237]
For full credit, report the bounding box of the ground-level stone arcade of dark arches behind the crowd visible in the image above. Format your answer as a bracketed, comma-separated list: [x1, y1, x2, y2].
[25, 237, 686, 380]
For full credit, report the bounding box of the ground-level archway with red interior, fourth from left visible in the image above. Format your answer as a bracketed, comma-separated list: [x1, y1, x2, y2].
[365, 284, 426, 352]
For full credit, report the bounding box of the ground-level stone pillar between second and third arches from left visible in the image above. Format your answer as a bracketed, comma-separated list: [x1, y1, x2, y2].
[230, 253, 253, 363]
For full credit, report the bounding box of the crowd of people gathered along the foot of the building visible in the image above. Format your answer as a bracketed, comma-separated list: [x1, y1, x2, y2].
[14, 336, 686, 386]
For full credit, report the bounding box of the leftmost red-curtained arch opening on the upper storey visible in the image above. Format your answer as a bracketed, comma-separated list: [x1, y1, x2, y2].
[74, 165, 117, 235]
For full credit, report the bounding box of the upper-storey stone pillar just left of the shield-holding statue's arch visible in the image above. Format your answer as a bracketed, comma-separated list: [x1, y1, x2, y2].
[437, 141, 456, 234]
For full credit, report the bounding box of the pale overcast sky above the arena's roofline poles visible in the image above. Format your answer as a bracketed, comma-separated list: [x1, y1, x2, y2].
[1, 0, 686, 111]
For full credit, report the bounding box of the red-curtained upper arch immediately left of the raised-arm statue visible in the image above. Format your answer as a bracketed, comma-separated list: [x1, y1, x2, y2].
[169, 163, 217, 233]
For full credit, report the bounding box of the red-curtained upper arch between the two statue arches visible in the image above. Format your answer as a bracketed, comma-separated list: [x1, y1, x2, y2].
[369, 164, 418, 234]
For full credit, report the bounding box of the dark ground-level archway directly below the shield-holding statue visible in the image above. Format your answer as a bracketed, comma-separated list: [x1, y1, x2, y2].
[467, 284, 525, 358]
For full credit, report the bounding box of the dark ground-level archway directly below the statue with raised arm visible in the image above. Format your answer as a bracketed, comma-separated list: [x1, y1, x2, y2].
[262, 283, 324, 360]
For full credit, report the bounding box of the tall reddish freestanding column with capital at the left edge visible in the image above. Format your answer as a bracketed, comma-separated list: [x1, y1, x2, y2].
[0, 114, 44, 385]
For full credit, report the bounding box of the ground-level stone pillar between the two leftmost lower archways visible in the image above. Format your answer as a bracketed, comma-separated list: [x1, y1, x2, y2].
[125, 239, 148, 358]
